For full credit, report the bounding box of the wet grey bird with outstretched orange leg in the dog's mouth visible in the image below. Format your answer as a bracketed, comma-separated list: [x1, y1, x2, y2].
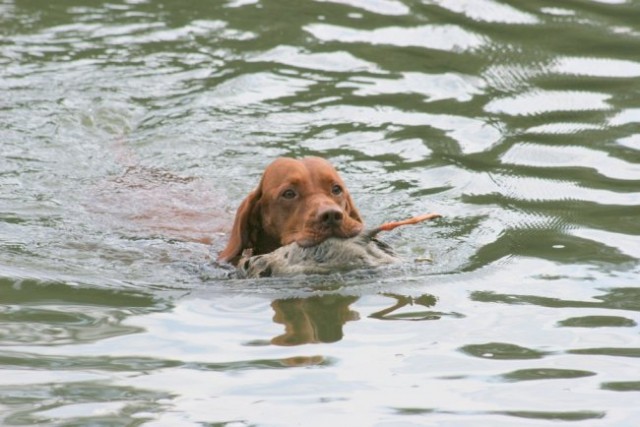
[237, 213, 441, 278]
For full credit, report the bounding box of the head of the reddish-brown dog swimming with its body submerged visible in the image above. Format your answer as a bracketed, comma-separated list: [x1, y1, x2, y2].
[218, 157, 363, 265]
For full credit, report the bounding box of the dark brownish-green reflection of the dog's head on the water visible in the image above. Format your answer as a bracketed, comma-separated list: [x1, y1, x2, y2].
[271, 295, 360, 346]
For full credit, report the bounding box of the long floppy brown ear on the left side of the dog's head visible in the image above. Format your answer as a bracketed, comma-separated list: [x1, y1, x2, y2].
[218, 187, 262, 265]
